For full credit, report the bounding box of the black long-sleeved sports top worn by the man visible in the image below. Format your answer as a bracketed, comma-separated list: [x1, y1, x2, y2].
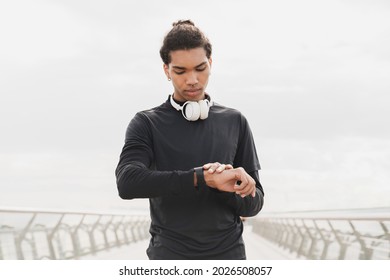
[116, 96, 264, 259]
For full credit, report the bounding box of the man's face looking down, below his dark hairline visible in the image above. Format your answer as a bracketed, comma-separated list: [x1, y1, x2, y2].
[164, 48, 211, 102]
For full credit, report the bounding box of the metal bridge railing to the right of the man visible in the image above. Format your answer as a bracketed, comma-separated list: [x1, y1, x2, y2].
[252, 210, 390, 260]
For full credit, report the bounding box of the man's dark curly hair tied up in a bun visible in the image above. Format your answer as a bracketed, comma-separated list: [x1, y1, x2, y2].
[160, 20, 212, 65]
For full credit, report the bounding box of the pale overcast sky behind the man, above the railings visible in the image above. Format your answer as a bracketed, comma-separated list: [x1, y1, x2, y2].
[0, 0, 390, 211]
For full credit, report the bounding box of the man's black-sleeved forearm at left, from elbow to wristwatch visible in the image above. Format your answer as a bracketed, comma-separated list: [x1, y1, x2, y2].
[115, 162, 195, 199]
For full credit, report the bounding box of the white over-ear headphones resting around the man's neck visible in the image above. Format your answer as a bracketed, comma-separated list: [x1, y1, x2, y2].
[169, 95, 213, 121]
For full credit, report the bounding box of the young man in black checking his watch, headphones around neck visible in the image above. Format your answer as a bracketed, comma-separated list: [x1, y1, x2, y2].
[116, 20, 264, 259]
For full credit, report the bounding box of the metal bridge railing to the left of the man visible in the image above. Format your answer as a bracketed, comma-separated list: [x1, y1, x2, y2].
[0, 209, 150, 260]
